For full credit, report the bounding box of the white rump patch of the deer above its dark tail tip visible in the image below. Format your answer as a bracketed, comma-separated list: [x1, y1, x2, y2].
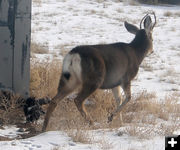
[62, 54, 81, 80]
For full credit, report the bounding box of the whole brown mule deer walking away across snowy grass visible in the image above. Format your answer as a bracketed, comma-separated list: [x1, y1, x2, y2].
[42, 13, 156, 131]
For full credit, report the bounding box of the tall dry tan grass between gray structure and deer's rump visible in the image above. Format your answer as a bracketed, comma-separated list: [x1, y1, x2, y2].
[30, 59, 61, 98]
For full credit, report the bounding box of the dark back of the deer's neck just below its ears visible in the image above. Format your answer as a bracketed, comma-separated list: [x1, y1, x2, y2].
[130, 30, 151, 64]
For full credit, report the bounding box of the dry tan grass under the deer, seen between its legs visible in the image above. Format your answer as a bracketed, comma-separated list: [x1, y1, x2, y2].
[45, 91, 119, 130]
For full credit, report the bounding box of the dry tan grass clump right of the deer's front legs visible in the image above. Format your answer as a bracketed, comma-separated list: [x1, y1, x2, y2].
[124, 92, 180, 124]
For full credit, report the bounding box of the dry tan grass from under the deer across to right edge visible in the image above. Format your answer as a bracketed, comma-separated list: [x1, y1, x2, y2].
[46, 87, 180, 134]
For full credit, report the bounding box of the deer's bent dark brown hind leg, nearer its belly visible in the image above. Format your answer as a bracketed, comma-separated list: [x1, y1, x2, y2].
[74, 50, 105, 125]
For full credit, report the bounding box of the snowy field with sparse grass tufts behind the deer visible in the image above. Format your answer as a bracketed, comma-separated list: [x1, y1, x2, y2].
[32, 0, 180, 99]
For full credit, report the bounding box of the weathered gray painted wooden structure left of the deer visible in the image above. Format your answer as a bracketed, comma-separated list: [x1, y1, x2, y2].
[0, 0, 31, 97]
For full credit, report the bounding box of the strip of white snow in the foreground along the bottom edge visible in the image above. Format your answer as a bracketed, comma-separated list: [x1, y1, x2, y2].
[0, 126, 165, 150]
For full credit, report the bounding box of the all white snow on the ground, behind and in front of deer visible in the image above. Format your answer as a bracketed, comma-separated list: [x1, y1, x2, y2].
[0, 0, 180, 150]
